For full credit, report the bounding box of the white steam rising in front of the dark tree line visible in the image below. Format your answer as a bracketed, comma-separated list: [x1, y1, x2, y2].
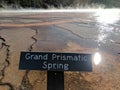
[0, 3, 105, 10]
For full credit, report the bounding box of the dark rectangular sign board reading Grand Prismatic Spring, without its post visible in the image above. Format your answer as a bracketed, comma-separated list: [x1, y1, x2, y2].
[19, 52, 92, 71]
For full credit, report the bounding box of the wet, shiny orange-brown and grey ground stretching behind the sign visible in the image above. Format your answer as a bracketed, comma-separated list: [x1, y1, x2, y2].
[0, 11, 120, 90]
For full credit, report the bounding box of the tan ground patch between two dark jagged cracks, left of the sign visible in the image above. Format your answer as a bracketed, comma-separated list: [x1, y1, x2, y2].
[0, 28, 36, 88]
